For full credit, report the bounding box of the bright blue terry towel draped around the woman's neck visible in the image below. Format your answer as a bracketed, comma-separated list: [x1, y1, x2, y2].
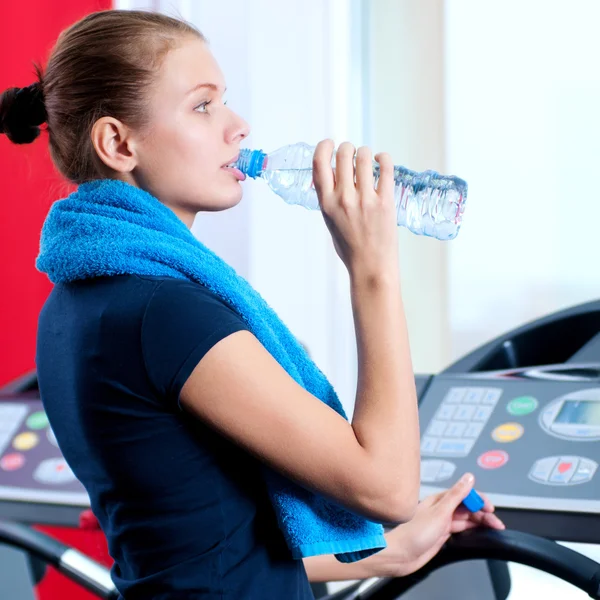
[36, 179, 386, 562]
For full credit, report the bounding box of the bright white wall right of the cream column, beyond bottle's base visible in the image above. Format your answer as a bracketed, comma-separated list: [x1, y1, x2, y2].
[445, 0, 600, 356]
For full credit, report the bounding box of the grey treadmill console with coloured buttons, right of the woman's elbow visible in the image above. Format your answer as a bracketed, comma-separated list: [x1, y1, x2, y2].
[419, 302, 600, 543]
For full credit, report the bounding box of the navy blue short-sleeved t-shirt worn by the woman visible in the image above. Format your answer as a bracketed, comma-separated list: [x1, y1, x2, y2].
[36, 275, 313, 600]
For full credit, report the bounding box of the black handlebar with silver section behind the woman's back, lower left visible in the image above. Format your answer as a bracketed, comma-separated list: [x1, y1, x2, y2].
[0, 520, 118, 600]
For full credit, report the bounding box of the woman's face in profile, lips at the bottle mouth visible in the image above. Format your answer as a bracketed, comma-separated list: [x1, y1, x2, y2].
[133, 37, 249, 227]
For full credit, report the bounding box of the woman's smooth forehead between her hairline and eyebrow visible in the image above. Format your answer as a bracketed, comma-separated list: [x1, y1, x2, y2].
[157, 37, 225, 96]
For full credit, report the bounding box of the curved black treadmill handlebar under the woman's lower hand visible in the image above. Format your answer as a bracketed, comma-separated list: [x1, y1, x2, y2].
[322, 529, 600, 600]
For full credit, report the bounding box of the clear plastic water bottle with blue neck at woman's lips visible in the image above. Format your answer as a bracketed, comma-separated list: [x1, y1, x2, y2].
[234, 143, 467, 240]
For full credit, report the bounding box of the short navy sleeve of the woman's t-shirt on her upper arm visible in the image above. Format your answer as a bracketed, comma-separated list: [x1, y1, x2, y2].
[141, 279, 249, 409]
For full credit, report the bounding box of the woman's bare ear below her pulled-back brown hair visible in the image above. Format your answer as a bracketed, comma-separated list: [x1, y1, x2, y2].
[91, 117, 137, 173]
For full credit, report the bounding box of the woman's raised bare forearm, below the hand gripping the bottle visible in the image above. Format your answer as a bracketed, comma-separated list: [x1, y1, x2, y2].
[352, 271, 420, 506]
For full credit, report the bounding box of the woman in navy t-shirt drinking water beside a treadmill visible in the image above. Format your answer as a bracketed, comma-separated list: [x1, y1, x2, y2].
[0, 11, 503, 600]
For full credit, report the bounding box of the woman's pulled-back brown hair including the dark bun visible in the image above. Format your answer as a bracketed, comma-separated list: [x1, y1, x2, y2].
[0, 10, 206, 184]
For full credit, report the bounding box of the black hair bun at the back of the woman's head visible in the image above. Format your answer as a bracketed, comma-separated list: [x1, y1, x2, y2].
[0, 82, 47, 144]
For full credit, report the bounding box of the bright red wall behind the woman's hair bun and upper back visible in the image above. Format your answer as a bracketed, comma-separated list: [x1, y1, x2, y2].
[0, 0, 111, 386]
